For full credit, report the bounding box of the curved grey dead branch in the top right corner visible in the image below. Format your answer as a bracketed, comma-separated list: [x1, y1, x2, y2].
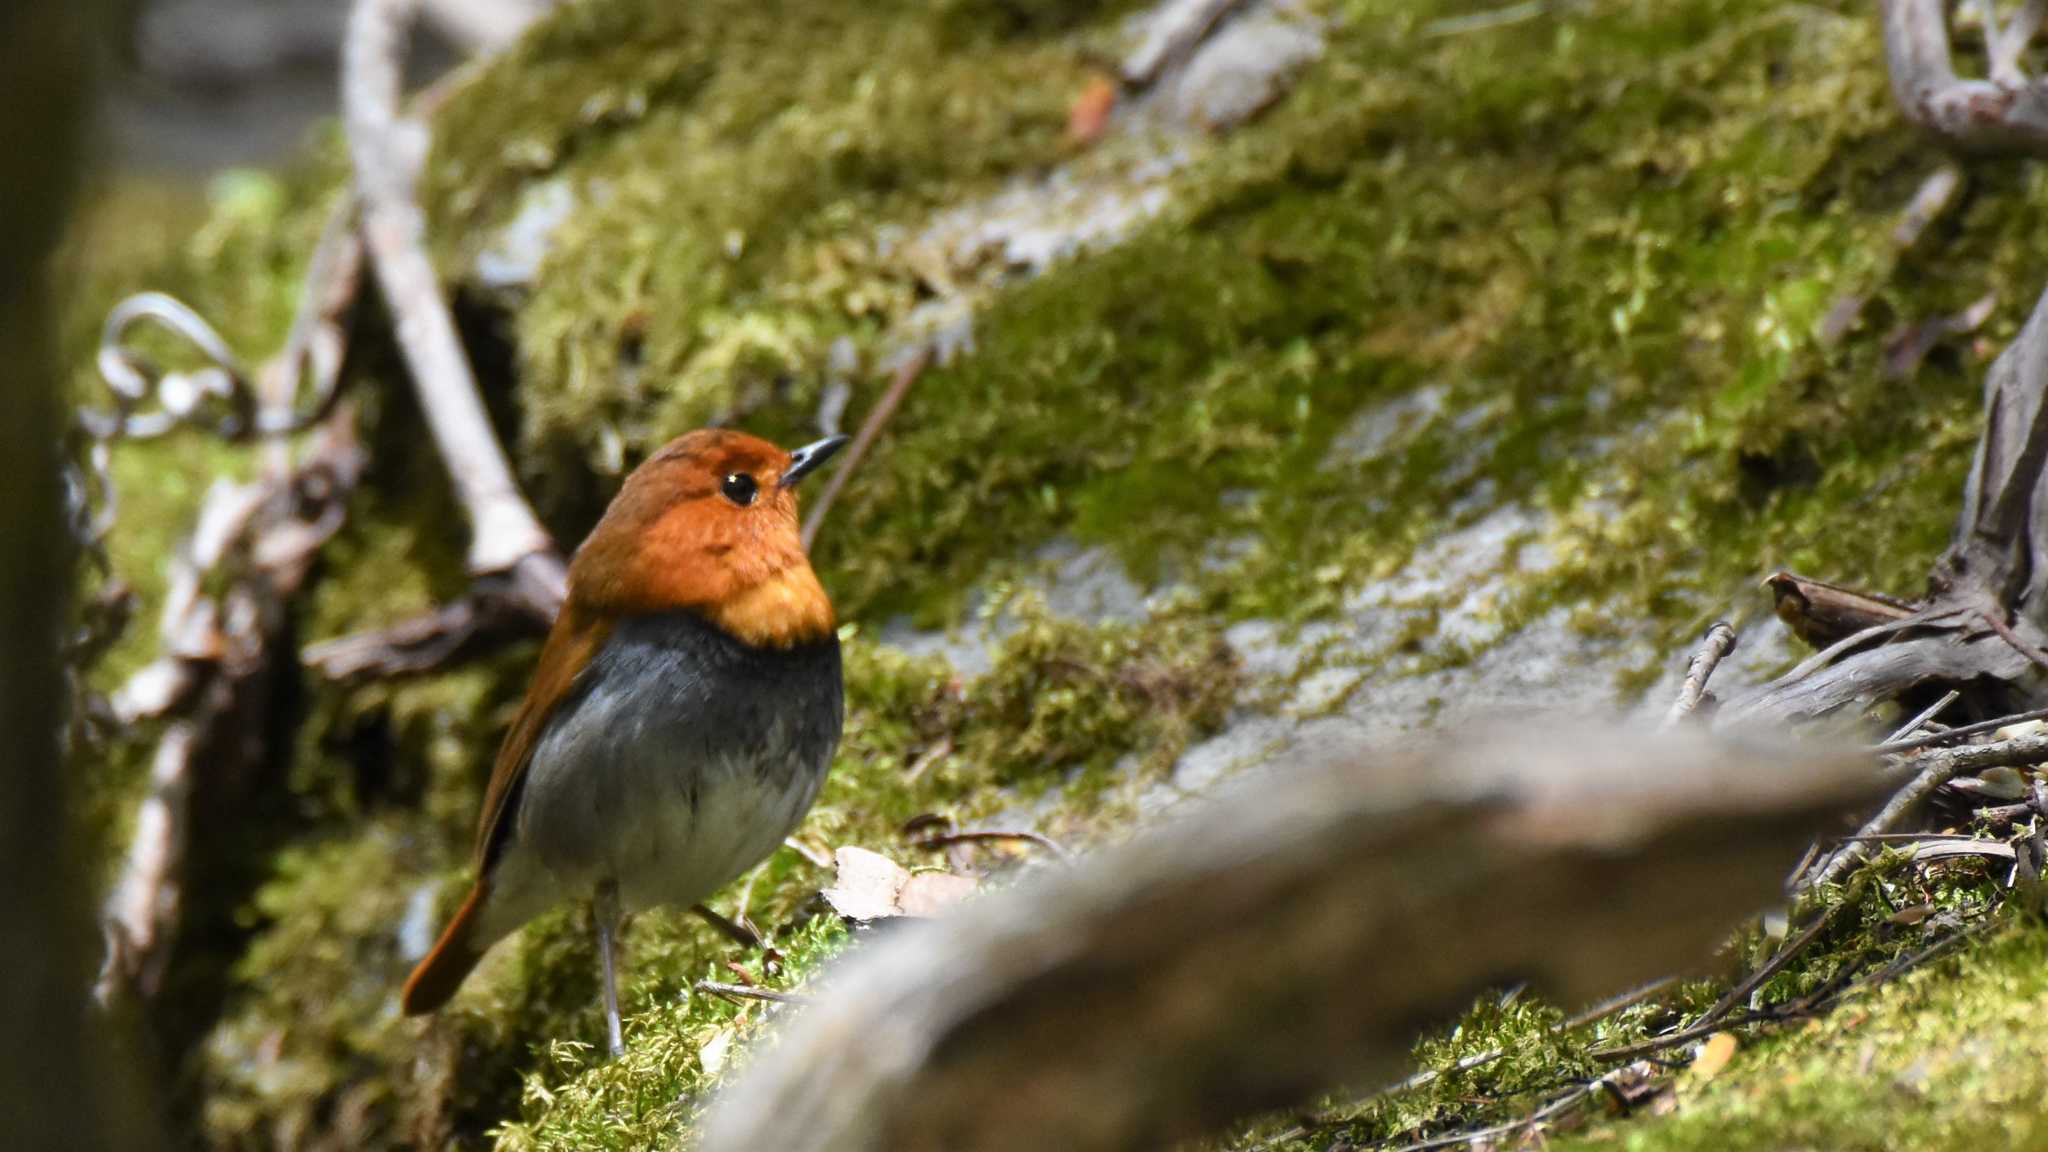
[1878, 0, 2048, 156]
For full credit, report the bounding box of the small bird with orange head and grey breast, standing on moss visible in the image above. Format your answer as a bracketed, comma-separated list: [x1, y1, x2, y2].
[399, 428, 846, 1056]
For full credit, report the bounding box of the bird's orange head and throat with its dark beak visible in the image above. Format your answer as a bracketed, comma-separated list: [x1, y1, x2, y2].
[569, 428, 846, 648]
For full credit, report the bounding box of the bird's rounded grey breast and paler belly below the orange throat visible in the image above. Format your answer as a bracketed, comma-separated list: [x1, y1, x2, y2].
[508, 615, 844, 908]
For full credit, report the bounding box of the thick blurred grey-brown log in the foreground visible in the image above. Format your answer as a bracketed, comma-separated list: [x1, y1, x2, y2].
[702, 730, 1880, 1152]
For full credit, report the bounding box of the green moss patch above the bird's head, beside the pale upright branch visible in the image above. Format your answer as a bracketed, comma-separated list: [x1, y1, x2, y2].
[428, 0, 1155, 491]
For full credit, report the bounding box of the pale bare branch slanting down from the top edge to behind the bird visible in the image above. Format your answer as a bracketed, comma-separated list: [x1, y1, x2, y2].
[331, 0, 567, 674]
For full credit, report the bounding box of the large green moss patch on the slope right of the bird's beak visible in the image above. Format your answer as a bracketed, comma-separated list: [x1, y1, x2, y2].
[823, 0, 2015, 668]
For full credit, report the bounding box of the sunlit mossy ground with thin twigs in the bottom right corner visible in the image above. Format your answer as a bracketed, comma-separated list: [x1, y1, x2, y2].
[1227, 844, 2048, 1152]
